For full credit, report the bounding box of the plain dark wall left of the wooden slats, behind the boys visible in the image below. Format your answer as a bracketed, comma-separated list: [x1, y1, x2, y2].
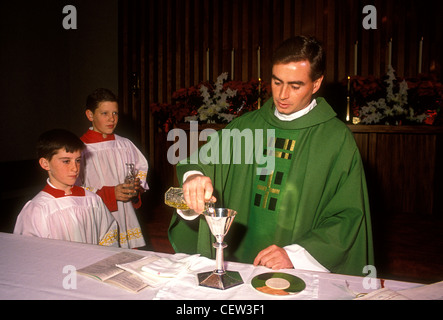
[0, 0, 119, 232]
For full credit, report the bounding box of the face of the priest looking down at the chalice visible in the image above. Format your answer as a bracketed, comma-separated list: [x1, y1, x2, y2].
[271, 60, 323, 115]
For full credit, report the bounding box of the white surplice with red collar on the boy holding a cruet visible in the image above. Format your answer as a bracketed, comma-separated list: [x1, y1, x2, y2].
[78, 129, 149, 248]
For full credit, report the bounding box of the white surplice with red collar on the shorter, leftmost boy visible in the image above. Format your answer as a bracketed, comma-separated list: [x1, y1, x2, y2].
[14, 182, 118, 246]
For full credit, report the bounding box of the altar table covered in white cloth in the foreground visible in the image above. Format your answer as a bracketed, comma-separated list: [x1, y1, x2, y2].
[0, 233, 434, 302]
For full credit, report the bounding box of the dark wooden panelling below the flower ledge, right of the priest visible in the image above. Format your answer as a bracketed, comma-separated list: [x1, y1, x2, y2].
[349, 125, 443, 217]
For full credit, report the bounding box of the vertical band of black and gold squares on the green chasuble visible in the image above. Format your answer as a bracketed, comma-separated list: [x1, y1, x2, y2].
[254, 137, 296, 211]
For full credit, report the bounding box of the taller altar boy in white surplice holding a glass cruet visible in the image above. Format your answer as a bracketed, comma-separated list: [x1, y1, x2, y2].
[77, 89, 149, 248]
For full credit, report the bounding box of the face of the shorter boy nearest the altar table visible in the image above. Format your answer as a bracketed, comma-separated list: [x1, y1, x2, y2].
[39, 148, 81, 191]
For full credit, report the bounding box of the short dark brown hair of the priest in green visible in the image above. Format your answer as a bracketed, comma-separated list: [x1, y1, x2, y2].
[272, 36, 326, 81]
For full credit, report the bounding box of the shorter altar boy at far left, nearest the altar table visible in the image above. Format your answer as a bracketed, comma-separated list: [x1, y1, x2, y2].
[14, 129, 118, 246]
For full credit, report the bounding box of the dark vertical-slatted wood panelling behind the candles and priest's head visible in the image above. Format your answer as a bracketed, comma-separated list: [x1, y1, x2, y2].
[119, 0, 443, 191]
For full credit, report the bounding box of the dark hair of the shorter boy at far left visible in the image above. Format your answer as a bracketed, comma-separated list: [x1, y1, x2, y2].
[37, 129, 85, 160]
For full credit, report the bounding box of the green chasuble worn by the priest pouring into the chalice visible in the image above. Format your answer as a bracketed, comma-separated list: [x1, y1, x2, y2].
[169, 98, 374, 276]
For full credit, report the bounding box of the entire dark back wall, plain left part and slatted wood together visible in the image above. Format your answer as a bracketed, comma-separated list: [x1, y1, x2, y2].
[0, 0, 443, 165]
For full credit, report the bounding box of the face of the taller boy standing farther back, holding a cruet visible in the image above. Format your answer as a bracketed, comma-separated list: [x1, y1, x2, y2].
[86, 101, 118, 137]
